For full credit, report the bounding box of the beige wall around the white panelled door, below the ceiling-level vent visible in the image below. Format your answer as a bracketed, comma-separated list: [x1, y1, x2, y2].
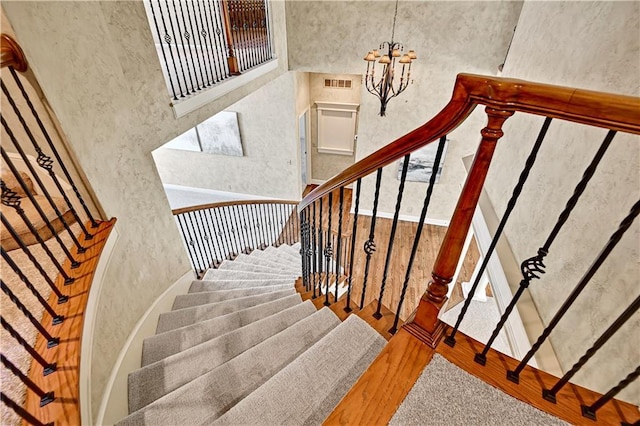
[309, 73, 361, 180]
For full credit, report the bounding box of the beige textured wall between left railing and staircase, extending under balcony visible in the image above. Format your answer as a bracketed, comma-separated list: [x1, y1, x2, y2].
[2, 1, 287, 416]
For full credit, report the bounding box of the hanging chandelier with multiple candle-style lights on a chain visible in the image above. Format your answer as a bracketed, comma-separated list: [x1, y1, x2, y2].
[364, 0, 417, 117]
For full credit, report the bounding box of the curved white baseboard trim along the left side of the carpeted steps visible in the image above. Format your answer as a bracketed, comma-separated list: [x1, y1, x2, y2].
[95, 271, 195, 425]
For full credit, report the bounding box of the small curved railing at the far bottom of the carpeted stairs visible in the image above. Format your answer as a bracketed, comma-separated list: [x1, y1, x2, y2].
[173, 200, 300, 278]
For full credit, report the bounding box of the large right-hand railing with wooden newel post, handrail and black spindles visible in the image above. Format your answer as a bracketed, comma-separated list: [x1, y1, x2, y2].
[298, 74, 640, 418]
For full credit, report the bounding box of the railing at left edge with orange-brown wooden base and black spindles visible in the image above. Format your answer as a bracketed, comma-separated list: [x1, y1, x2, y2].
[0, 34, 113, 425]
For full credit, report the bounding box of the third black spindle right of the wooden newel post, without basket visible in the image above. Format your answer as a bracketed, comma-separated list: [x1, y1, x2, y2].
[507, 200, 640, 383]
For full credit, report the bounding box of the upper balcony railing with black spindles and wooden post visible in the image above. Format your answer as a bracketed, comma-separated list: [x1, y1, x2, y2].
[145, 0, 273, 101]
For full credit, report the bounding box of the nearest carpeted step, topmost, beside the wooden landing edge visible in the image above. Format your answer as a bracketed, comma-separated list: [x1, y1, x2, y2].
[212, 315, 386, 425]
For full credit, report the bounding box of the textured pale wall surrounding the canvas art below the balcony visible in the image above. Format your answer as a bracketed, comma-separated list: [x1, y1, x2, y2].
[153, 73, 300, 200]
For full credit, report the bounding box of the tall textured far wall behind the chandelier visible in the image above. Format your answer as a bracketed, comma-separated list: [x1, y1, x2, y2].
[286, 1, 521, 220]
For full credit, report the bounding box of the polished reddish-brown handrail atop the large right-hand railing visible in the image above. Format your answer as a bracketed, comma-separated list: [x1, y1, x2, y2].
[298, 74, 640, 211]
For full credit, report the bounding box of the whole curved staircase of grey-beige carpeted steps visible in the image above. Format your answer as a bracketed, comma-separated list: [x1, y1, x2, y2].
[119, 245, 386, 425]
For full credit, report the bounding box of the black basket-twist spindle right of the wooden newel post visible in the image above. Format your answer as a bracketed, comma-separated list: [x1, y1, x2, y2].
[474, 130, 616, 365]
